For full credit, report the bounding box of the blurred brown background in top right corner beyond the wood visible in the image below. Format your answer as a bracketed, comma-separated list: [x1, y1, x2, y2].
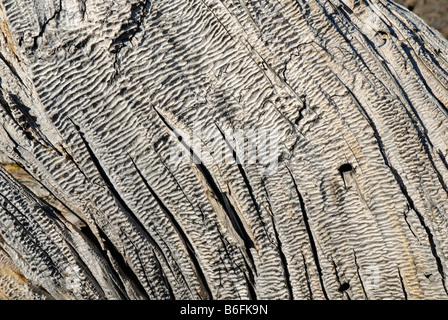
[394, 0, 448, 39]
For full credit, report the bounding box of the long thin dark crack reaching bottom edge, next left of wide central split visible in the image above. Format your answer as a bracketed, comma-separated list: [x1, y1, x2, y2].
[129, 156, 213, 299]
